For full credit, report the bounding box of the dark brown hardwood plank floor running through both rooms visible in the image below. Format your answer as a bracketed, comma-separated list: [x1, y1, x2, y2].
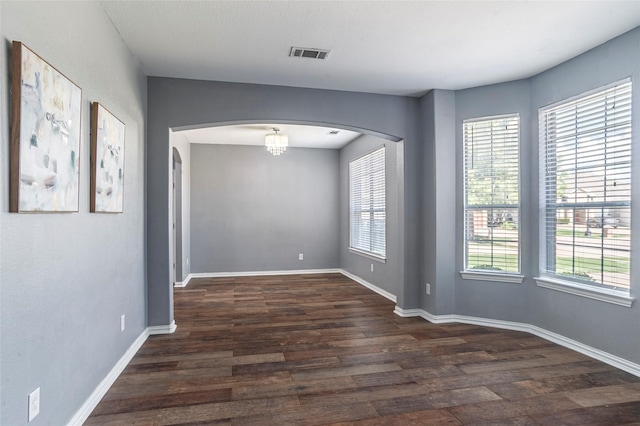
[86, 274, 640, 425]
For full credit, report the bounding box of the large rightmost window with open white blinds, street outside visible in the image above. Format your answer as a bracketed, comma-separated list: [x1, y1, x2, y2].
[539, 80, 631, 292]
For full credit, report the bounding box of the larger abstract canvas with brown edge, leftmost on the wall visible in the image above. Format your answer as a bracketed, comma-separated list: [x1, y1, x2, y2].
[9, 41, 82, 212]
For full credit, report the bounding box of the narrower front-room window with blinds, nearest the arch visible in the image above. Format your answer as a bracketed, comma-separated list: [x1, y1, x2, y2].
[463, 115, 520, 273]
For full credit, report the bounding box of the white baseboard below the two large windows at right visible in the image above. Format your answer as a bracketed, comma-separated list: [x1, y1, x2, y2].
[394, 306, 640, 377]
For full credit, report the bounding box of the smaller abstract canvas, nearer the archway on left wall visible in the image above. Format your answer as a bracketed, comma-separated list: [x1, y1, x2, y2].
[89, 102, 125, 213]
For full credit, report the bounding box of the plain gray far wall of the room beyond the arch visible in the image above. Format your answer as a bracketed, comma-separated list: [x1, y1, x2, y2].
[191, 144, 340, 273]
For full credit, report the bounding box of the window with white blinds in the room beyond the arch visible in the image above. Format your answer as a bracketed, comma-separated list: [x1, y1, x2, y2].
[349, 146, 386, 259]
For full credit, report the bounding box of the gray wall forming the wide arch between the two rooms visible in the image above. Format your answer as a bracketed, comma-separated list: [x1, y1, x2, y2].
[147, 77, 421, 325]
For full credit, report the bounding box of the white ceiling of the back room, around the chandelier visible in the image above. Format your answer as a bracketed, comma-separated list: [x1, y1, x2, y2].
[181, 123, 361, 149]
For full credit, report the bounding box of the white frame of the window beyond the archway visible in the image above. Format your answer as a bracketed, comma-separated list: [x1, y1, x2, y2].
[348, 145, 387, 263]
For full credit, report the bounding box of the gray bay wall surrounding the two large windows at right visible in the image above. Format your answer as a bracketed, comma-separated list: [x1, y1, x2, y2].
[455, 28, 640, 363]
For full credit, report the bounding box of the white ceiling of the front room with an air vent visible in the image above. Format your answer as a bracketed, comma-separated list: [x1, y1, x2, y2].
[101, 0, 640, 149]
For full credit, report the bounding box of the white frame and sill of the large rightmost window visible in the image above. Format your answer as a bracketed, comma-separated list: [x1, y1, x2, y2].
[534, 78, 634, 307]
